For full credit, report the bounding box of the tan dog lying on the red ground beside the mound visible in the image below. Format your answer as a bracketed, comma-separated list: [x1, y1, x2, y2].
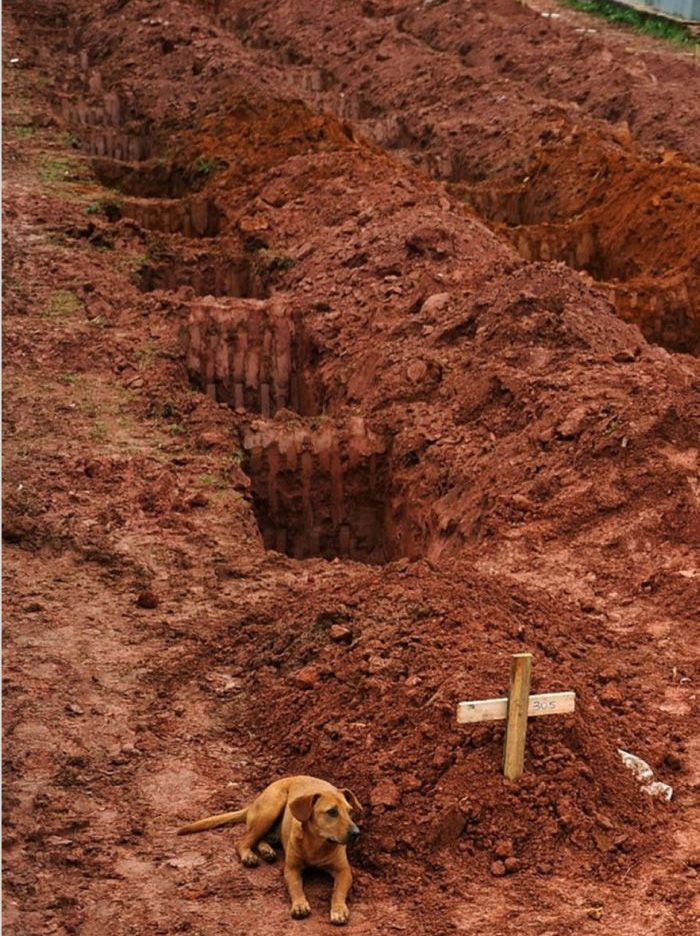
[178, 776, 362, 926]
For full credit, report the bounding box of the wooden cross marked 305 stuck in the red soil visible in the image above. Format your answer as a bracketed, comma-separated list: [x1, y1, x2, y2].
[457, 653, 576, 780]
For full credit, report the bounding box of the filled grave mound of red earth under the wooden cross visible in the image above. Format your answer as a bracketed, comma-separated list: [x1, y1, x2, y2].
[219, 557, 672, 887]
